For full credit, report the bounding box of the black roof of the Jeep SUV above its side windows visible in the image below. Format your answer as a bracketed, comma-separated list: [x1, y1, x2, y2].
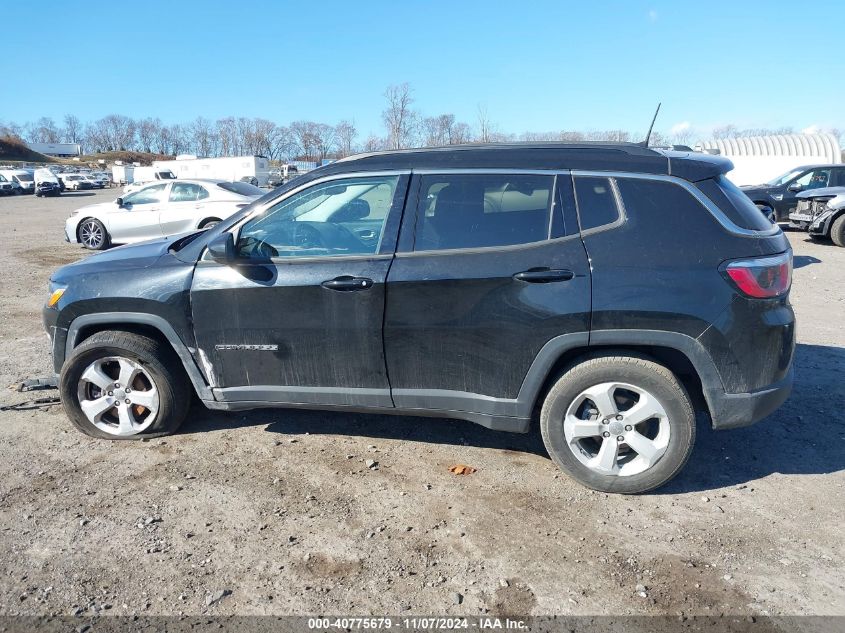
[314, 142, 733, 183]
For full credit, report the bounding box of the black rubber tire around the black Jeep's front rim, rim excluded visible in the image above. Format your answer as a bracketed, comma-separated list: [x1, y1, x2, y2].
[59, 331, 194, 440]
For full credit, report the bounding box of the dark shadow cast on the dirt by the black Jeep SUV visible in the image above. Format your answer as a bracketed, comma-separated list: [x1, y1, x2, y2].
[180, 344, 845, 494]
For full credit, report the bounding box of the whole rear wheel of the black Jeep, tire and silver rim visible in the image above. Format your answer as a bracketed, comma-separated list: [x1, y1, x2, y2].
[540, 355, 695, 494]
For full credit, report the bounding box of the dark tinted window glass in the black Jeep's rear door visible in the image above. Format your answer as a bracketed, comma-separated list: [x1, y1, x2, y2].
[414, 174, 554, 251]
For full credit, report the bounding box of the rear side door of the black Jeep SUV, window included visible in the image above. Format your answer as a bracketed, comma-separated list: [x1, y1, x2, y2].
[385, 171, 590, 417]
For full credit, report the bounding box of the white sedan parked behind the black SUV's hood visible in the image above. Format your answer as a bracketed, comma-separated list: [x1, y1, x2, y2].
[65, 180, 264, 250]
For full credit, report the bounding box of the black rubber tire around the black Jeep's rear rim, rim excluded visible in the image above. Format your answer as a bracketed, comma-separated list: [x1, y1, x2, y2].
[540, 352, 695, 494]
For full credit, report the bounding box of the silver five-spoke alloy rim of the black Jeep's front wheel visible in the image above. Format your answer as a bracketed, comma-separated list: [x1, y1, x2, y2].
[77, 356, 159, 436]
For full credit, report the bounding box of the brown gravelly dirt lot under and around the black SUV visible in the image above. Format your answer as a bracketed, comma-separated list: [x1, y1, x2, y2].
[0, 190, 845, 616]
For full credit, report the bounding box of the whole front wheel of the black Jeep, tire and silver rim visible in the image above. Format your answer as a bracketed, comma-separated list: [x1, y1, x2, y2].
[59, 331, 192, 439]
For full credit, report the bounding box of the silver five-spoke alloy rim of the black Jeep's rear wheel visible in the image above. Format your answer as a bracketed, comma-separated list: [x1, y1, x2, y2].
[563, 382, 671, 477]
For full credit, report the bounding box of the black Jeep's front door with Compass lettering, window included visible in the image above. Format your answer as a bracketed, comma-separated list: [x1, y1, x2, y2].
[191, 173, 408, 407]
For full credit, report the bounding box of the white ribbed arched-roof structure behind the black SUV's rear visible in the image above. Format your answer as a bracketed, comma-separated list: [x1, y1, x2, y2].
[695, 134, 842, 185]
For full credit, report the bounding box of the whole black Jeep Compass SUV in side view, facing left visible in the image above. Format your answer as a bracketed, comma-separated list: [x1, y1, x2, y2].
[44, 144, 795, 493]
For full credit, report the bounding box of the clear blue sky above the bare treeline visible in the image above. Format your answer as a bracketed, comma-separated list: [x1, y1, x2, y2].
[0, 0, 845, 137]
